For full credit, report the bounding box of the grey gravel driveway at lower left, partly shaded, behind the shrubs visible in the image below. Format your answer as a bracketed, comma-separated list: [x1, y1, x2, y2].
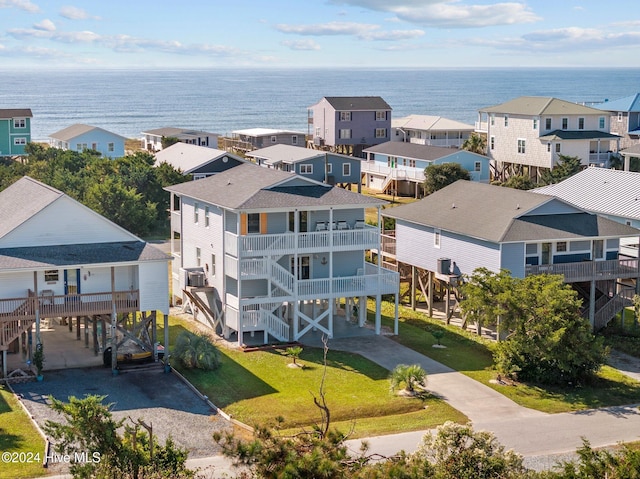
[13, 368, 231, 470]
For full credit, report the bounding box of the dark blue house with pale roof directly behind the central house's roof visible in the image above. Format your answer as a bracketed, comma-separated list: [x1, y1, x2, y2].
[247, 145, 362, 192]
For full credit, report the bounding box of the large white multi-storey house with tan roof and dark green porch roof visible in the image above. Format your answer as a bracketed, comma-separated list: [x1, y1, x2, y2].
[476, 96, 619, 181]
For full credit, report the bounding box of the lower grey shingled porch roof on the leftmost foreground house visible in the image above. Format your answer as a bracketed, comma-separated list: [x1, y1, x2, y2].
[0, 241, 171, 270]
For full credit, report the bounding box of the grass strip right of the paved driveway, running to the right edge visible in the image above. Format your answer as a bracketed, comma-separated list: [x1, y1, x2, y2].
[383, 303, 640, 413]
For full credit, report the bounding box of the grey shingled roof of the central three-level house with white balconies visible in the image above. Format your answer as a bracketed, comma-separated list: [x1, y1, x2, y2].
[165, 163, 386, 210]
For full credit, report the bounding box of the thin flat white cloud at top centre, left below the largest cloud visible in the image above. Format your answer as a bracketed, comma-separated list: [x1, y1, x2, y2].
[276, 22, 424, 40]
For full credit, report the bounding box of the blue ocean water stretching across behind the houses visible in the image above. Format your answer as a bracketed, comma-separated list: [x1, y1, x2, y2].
[0, 68, 640, 141]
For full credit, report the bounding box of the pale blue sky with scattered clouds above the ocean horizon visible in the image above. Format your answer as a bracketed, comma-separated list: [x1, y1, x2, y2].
[0, 0, 640, 69]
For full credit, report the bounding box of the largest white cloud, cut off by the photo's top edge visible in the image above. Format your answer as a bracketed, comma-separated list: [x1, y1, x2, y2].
[332, 0, 541, 28]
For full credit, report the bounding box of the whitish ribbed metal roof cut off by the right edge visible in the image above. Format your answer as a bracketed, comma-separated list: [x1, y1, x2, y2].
[533, 166, 640, 220]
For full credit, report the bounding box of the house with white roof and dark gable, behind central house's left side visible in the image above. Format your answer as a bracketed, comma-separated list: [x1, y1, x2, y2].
[155, 142, 246, 180]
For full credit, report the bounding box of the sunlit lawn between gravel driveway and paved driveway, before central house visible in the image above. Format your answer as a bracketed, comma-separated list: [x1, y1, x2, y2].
[160, 318, 467, 438]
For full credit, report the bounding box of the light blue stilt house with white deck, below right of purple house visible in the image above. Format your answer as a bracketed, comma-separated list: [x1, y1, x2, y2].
[362, 141, 491, 198]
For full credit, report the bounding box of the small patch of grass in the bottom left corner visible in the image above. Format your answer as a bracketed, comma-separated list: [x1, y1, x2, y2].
[0, 386, 47, 479]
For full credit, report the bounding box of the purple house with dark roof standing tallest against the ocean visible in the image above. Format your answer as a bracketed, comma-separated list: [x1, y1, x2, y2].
[308, 96, 391, 156]
